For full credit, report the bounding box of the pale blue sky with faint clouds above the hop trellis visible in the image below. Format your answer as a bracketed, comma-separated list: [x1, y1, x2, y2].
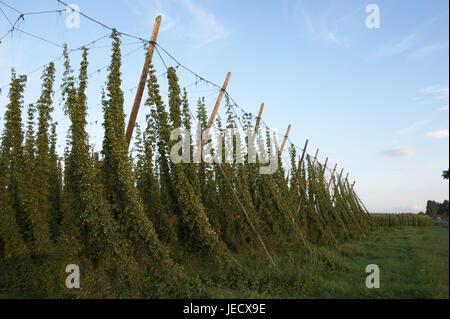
[0, 0, 449, 212]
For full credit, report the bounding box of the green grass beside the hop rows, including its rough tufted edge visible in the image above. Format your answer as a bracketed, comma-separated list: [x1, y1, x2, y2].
[205, 225, 449, 299]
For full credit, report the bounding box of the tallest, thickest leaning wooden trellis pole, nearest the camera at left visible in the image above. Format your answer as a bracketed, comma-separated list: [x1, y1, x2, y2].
[126, 16, 161, 147]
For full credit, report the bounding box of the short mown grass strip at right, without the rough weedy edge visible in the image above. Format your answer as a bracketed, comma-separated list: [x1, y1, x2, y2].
[308, 225, 449, 299]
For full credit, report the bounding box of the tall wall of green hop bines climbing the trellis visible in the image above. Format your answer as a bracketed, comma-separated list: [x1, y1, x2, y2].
[0, 35, 422, 298]
